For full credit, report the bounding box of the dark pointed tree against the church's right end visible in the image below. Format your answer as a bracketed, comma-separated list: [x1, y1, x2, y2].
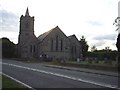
[80, 36, 89, 60]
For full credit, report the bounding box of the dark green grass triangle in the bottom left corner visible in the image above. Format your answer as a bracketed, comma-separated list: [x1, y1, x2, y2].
[2, 75, 26, 89]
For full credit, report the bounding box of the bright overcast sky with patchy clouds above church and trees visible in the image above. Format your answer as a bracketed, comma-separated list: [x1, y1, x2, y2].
[0, 0, 119, 50]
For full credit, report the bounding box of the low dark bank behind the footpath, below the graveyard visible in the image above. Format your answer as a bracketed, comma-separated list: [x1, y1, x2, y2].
[44, 60, 118, 72]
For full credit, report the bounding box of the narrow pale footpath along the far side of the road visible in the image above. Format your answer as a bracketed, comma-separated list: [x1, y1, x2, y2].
[41, 64, 119, 77]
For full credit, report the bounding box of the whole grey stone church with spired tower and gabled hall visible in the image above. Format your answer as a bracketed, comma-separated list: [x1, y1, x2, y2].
[18, 8, 81, 60]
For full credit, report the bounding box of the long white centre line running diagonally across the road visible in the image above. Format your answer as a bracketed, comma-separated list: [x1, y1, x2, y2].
[2, 63, 120, 89]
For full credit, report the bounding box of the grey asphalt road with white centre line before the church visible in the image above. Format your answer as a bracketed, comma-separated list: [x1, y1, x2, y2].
[2, 60, 118, 88]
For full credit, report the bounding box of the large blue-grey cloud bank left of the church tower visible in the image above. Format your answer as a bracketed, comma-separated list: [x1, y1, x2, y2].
[0, 10, 19, 32]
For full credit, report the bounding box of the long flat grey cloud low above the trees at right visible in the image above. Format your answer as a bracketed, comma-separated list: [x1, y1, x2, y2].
[93, 34, 117, 40]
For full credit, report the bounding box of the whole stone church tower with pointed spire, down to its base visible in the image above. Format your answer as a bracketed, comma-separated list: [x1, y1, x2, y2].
[18, 8, 37, 58]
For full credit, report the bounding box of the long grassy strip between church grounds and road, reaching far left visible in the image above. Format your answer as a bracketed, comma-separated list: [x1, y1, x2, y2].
[4, 59, 118, 73]
